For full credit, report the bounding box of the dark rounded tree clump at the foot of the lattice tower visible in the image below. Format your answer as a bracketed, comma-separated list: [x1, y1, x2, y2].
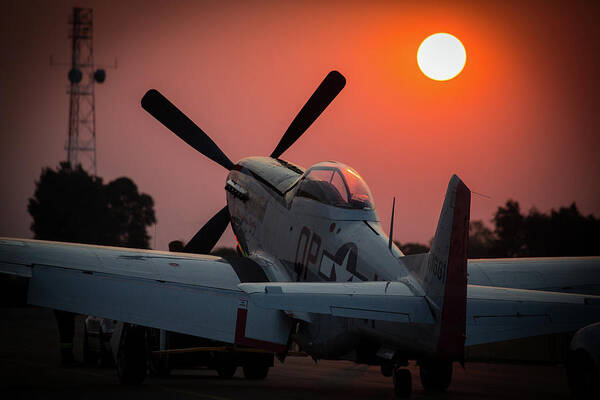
[27, 162, 156, 248]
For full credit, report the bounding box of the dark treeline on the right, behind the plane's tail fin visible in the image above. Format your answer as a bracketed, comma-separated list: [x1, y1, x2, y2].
[396, 200, 600, 258]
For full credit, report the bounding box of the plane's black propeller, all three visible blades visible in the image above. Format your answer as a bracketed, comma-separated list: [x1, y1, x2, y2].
[142, 71, 346, 254]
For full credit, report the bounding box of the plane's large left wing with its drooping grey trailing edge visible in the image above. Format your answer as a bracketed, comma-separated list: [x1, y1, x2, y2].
[0, 238, 292, 350]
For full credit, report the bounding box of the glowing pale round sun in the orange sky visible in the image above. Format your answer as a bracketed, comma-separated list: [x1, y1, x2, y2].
[417, 33, 467, 81]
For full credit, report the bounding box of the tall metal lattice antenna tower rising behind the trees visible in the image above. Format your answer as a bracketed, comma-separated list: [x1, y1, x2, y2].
[66, 7, 106, 175]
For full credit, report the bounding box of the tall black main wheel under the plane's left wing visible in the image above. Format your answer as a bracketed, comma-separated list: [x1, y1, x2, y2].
[117, 324, 148, 385]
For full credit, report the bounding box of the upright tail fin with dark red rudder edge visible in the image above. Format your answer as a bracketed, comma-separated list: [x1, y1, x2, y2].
[403, 175, 471, 360]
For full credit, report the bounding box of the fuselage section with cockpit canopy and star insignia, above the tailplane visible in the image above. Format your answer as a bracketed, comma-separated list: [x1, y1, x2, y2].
[226, 157, 408, 282]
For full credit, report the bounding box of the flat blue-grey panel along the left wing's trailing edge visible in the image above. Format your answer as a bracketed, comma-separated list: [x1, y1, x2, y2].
[28, 265, 243, 343]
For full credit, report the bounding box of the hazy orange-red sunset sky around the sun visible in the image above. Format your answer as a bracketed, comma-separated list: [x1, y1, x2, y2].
[0, 1, 600, 249]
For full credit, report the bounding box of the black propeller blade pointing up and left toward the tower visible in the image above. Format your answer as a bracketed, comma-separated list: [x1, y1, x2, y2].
[142, 89, 233, 170]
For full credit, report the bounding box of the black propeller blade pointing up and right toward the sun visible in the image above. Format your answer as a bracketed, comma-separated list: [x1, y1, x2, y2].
[271, 71, 346, 158]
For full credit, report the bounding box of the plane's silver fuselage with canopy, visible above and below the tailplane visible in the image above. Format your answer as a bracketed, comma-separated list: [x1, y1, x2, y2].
[225, 157, 431, 363]
